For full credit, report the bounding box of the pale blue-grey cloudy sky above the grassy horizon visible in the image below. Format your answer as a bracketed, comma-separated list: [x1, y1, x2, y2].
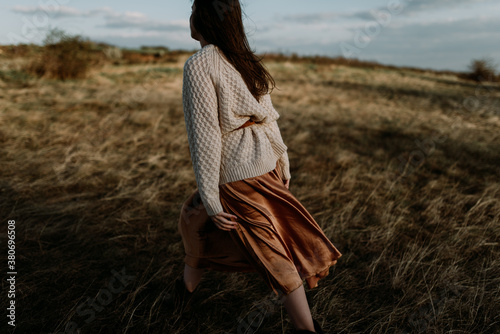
[0, 0, 500, 71]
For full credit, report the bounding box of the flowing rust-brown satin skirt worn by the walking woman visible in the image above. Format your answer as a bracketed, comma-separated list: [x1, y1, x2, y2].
[178, 163, 342, 295]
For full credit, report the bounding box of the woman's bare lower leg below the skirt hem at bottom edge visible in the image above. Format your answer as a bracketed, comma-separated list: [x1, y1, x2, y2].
[284, 285, 314, 332]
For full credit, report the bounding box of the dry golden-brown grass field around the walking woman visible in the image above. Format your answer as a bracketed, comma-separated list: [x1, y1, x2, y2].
[0, 43, 500, 334]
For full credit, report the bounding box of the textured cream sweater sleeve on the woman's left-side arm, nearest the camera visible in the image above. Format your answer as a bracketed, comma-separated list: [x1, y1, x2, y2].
[182, 57, 223, 216]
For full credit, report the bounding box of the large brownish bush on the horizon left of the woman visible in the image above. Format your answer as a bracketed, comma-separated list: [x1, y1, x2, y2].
[26, 28, 99, 80]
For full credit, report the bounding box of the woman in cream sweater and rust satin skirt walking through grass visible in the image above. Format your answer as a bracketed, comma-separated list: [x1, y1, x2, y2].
[170, 0, 342, 333]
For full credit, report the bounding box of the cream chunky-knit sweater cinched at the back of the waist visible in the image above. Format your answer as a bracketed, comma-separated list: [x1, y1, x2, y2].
[182, 44, 291, 216]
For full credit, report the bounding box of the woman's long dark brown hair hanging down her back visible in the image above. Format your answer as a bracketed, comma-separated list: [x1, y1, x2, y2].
[193, 0, 276, 101]
